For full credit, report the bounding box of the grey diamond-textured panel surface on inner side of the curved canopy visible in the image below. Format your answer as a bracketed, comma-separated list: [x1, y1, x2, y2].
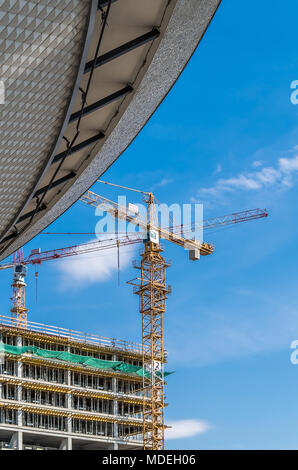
[0, 0, 90, 233]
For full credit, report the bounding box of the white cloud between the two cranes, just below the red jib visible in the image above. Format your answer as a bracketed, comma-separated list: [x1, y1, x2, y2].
[55, 240, 134, 288]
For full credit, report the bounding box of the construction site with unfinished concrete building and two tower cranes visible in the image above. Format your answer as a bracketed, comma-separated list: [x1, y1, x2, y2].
[0, 182, 268, 450]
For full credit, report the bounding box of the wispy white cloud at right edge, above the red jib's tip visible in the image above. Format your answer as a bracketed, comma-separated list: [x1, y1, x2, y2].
[200, 155, 298, 196]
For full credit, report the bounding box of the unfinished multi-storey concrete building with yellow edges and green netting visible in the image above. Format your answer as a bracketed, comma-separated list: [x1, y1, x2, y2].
[0, 316, 144, 450]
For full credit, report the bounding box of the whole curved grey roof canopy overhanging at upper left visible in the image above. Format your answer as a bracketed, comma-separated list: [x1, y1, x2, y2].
[0, 0, 220, 259]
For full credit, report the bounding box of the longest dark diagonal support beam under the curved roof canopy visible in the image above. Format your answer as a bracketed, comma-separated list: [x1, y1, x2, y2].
[84, 28, 160, 73]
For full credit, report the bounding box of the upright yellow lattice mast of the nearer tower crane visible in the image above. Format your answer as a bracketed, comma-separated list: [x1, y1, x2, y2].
[129, 193, 170, 450]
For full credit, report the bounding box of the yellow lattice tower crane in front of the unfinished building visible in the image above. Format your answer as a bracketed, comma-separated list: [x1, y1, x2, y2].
[80, 180, 268, 450]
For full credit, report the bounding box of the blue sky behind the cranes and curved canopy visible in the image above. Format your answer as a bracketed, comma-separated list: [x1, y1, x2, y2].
[0, 0, 298, 449]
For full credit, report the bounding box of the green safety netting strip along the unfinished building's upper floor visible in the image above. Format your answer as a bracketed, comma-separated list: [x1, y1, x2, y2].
[0, 342, 172, 377]
